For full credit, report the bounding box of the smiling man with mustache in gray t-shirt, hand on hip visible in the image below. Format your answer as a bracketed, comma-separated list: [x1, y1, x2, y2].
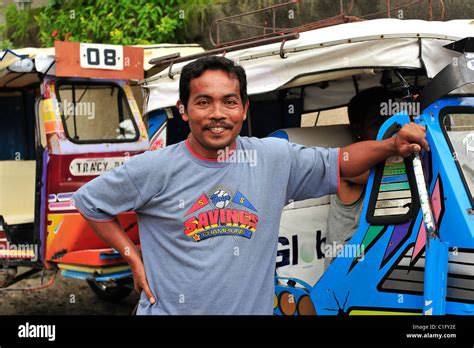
[74, 57, 428, 315]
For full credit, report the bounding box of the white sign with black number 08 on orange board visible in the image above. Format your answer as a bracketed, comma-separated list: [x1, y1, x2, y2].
[80, 44, 123, 70]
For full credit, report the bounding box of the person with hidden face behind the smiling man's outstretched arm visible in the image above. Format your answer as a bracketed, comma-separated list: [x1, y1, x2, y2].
[324, 87, 395, 269]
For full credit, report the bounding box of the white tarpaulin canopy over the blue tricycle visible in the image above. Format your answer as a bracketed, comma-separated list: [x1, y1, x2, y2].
[143, 19, 474, 112]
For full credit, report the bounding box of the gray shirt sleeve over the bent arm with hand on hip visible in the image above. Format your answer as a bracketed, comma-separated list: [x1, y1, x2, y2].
[72, 156, 144, 222]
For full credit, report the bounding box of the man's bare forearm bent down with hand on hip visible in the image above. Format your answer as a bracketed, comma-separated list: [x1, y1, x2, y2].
[86, 218, 155, 304]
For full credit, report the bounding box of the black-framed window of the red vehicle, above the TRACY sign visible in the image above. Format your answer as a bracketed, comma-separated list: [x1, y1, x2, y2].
[57, 82, 138, 143]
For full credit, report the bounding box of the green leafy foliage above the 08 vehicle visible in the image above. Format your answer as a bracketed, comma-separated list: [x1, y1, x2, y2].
[36, 0, 213, 46]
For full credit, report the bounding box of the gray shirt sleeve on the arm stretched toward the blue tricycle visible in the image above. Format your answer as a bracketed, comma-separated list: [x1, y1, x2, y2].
[286, 143, 340, 203]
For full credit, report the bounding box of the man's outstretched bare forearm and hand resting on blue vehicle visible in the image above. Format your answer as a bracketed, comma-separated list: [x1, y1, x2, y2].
[339, 123, 429, 177]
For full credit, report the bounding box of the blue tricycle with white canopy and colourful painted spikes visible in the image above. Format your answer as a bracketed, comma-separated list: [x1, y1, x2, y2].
[143, 19, 474, 315]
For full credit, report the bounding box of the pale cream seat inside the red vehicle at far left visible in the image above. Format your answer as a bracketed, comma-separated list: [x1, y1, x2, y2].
[0, 161, 36, 225]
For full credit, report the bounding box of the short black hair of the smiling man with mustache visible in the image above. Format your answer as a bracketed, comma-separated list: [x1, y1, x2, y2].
[179, 56, 248, 107]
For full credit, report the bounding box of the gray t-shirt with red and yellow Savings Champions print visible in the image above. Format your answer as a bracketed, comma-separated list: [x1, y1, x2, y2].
[73, 137, 339, 315]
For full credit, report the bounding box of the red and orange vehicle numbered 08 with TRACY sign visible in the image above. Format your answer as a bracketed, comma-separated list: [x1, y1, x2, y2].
[0, 42, 148, 294]
